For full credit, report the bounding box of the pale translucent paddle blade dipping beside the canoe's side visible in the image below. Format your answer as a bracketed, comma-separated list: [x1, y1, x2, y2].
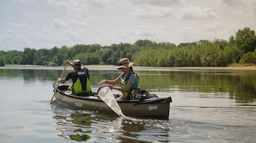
[98, 86, 124, 117]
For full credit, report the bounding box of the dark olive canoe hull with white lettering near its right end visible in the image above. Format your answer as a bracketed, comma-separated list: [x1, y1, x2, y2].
[55, 86, 171, 120]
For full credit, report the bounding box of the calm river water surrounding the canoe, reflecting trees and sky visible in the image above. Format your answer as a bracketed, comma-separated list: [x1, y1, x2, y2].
[0, 68, 256, 143]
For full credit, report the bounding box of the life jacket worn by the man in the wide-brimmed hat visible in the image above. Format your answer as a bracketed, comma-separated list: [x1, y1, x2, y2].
[121, 71, 139, 100]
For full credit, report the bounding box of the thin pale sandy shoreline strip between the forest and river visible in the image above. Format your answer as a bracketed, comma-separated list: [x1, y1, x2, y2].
[0, 65, 256, 71]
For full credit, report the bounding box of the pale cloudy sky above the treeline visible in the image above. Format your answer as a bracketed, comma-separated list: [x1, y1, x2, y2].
[0, 0, 256, 51]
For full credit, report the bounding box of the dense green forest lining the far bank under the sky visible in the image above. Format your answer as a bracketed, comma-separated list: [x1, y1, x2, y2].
[0, 27, 256, 67]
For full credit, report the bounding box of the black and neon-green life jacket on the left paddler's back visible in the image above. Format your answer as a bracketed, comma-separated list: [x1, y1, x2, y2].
[72, 69, 92, 95]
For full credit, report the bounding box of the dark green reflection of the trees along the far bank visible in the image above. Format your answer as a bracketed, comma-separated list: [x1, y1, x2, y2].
[0, 69, 256, 103]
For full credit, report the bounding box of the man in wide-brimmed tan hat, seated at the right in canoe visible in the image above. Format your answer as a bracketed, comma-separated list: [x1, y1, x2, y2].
[99, 58, 139, 100]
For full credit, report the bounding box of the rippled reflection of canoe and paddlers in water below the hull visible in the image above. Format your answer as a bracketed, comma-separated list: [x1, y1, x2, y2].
[52, 103, 173, 143]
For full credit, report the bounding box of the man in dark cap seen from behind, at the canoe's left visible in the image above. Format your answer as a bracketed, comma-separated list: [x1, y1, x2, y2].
[59, 59, 92, 96]
